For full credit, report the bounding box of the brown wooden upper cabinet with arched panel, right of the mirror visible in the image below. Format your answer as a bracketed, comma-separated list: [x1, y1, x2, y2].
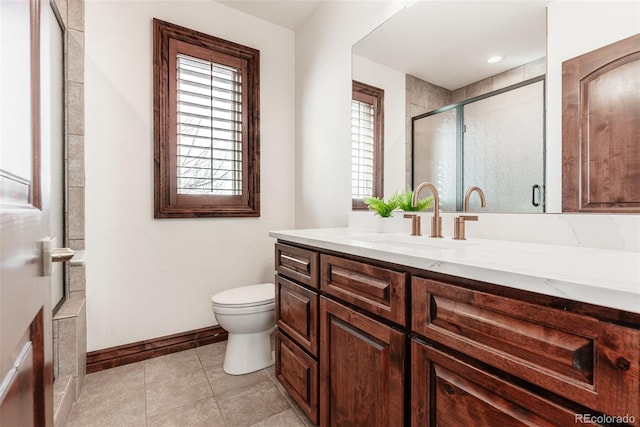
[562, 34, 640, 212]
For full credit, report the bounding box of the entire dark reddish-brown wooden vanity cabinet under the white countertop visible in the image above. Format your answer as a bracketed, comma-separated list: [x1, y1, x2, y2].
[276, 242, 640, 427]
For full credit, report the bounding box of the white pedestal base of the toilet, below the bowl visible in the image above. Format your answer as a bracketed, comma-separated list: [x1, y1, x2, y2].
[222, 328, 274, 375]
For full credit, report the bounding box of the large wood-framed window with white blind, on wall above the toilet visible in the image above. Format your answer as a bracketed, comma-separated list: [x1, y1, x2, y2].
[154, 19, 260, 218]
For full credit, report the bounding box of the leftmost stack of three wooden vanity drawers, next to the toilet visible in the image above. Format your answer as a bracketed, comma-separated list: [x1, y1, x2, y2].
[275, 243, 319, 424]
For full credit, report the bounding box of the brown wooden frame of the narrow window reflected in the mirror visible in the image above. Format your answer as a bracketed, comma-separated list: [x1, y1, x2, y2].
[351, 80, 384, 210]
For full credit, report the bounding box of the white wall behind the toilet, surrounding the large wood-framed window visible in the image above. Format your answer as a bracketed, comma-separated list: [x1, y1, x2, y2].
[85, 0, 295, 351]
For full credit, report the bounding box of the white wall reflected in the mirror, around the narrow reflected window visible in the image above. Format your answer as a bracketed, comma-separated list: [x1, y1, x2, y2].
[352, 55, 406, 197]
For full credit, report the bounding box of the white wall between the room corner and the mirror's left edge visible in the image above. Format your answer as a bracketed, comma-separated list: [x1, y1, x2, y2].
[295, 0, 406, 228]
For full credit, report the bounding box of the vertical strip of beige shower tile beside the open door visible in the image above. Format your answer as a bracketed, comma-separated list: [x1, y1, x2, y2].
[50, 0, 87, 426]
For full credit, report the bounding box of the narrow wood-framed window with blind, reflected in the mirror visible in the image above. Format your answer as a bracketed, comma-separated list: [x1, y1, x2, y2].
[351, 81, 384, 209]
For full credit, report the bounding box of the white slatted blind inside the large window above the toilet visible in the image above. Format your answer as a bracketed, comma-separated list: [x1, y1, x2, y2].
[176, 54, 242, 195]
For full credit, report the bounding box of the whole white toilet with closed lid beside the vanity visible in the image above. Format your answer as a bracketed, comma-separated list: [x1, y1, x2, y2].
[211, 283, 275, 375]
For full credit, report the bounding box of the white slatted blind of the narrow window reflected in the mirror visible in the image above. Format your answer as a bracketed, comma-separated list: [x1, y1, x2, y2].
[351, 99, 375, 199]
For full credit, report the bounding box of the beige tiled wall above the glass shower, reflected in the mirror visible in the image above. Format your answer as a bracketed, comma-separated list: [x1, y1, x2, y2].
[405, 57, 547, 188]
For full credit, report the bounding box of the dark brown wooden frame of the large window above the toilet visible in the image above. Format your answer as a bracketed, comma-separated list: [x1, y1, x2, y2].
[153, 18, 260, 218]
